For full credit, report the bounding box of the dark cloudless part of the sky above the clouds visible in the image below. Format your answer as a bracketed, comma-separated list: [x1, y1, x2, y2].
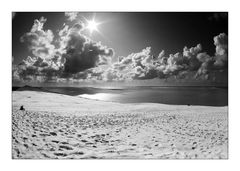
[12, 12, 228, 86]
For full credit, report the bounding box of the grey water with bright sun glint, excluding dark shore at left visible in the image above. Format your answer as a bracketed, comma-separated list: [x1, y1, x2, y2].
[79, 87, 228, 106]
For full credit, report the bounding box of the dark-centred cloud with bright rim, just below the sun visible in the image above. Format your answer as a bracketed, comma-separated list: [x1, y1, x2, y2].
[61, 23, 114, 74]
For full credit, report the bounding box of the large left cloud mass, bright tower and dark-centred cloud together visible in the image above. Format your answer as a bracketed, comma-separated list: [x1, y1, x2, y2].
[13, 17, 114, 81]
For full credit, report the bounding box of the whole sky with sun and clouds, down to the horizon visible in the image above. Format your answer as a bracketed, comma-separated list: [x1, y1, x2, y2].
[12, 12, 228, 86]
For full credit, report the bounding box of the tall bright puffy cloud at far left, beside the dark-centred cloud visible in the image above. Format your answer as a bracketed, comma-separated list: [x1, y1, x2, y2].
[13, 17, 63, 81]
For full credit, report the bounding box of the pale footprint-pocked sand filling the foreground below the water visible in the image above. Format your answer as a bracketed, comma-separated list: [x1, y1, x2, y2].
[12, 91, 228, 159]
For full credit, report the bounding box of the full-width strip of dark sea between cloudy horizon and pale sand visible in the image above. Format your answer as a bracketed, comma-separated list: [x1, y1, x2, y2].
[13, 86, 228, 106]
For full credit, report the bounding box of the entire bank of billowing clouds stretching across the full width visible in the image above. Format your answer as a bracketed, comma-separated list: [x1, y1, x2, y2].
[12, 14, 228, 81]
